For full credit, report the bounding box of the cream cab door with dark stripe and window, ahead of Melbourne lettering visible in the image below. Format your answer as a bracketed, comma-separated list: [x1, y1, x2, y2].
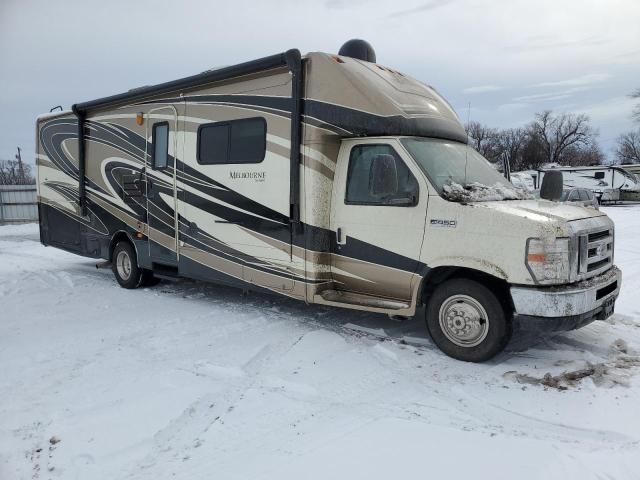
[331, 141, 428, 300]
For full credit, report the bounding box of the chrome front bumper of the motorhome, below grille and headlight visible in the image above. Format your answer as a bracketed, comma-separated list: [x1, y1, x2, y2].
[511, 266, 622, 330]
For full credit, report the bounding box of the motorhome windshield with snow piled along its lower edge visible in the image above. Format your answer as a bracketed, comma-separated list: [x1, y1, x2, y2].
[401, 137, 530, 202]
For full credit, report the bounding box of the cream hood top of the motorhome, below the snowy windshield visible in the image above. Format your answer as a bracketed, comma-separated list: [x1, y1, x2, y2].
[476, 200, 605, 222]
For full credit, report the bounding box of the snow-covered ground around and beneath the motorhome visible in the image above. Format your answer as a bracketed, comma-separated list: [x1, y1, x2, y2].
[0, 205, 640, 480]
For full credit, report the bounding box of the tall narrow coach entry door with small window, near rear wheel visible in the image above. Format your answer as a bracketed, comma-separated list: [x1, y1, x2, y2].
[145, 106, 179, 266]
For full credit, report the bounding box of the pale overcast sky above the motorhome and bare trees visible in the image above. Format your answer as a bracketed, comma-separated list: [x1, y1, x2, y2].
[0, 0, 640, 163]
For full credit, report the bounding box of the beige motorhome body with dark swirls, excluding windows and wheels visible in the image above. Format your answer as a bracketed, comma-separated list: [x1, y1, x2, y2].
[37, 47, 620, 342]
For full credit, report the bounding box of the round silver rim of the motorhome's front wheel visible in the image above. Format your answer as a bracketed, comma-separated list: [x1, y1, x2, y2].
[439, 295, 489, 347]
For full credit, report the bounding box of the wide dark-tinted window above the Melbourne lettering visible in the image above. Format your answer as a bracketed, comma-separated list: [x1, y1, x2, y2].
[197, 118, 267, 165]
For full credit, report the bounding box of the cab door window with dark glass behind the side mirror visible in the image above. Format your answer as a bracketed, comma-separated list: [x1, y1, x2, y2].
[345, 145, 418, 207]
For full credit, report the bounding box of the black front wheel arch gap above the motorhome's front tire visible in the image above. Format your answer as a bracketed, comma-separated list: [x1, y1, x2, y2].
[421, 267, 513, 313]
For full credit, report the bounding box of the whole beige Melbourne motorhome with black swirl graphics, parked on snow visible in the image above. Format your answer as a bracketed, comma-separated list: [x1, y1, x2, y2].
[37, 41, 621, 361]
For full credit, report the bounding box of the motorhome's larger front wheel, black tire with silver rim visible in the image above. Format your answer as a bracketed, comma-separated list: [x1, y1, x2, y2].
[426, 278, 512, 362]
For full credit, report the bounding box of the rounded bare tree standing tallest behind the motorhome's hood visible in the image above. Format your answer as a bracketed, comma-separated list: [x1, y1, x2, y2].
[530, 110, 597, 163]
